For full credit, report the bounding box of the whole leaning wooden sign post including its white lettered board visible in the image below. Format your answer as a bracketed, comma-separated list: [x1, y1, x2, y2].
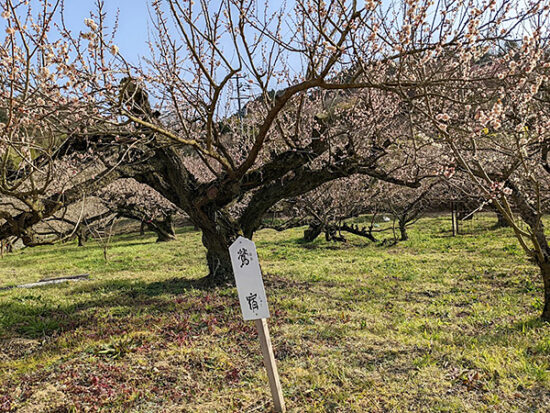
[229, 237, 286, 412]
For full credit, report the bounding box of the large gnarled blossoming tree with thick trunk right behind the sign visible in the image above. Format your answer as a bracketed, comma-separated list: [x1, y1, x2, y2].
[0, 0, 540, 283]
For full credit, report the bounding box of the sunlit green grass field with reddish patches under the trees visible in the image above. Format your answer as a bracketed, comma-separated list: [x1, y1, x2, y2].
[0, 217, 550, 412]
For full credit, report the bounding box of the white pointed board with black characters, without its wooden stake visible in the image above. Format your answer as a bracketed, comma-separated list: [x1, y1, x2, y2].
[229, 237, 269, 320]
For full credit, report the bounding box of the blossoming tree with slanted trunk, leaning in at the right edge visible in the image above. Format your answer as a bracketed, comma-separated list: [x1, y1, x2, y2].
[411, 1, 550, 321]
